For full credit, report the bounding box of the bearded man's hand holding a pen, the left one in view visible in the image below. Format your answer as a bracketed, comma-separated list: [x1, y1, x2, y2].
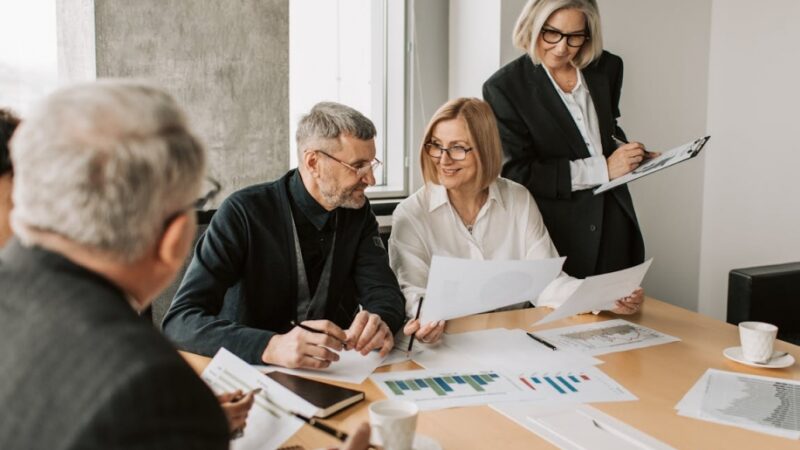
[261, 320, 347, 369]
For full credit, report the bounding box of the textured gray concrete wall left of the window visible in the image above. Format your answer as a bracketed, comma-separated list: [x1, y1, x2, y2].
[94, 0, 289, 203]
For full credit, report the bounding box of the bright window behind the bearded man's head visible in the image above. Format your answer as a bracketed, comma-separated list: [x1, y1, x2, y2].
[289, 0, 408, 198]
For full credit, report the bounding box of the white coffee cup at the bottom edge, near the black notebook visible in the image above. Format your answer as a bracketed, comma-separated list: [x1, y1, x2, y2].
[369, 400, 419, 450]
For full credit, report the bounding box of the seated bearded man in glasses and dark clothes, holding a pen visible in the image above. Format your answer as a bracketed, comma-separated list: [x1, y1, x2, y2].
[164, 102, 405, 369]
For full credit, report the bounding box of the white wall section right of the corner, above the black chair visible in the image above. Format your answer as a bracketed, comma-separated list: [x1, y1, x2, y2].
[699, 0, 800, 318]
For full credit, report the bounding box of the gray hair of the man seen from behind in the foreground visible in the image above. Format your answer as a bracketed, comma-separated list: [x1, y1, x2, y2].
[11, 80, 206, 262]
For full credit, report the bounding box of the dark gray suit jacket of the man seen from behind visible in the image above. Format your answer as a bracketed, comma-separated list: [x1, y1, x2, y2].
[0, 240, 229, 449]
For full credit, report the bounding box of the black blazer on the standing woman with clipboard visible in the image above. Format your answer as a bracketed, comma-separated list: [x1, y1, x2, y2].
[483, 52, 644, 277]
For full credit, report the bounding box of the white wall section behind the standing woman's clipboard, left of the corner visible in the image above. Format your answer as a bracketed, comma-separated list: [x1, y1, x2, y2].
[599, 0, 715, 309]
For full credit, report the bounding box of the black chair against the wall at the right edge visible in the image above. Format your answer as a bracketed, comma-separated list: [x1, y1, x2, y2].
[727, 262, 800, 345]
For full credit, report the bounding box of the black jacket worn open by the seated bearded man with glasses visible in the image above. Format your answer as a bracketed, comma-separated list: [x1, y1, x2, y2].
[163, 170, 405, 364]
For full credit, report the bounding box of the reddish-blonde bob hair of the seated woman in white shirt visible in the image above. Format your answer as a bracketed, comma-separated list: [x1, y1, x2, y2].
[419, 97, 503, 189]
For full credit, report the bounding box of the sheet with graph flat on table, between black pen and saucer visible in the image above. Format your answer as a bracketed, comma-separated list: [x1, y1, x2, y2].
[536, 319, 680, 356]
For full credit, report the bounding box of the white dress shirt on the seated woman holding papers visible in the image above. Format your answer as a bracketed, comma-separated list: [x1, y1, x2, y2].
[389, 178, 581, 317]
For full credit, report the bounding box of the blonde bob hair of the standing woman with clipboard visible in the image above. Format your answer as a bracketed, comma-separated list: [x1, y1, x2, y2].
[511, 0, 603, 69]
